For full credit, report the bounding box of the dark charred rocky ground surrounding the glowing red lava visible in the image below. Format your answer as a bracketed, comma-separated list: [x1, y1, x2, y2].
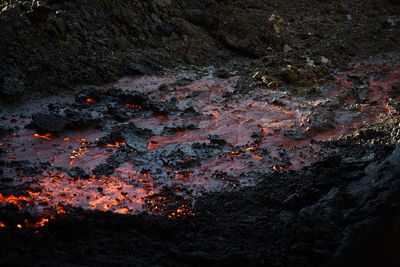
[0, 0, 400, 266]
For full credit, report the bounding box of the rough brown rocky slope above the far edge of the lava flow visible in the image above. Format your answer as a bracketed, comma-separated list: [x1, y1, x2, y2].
[0, 0, 400, 98]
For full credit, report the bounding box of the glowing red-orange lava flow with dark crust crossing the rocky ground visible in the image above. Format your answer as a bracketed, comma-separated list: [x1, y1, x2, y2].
[0, 55, 400, 228]
